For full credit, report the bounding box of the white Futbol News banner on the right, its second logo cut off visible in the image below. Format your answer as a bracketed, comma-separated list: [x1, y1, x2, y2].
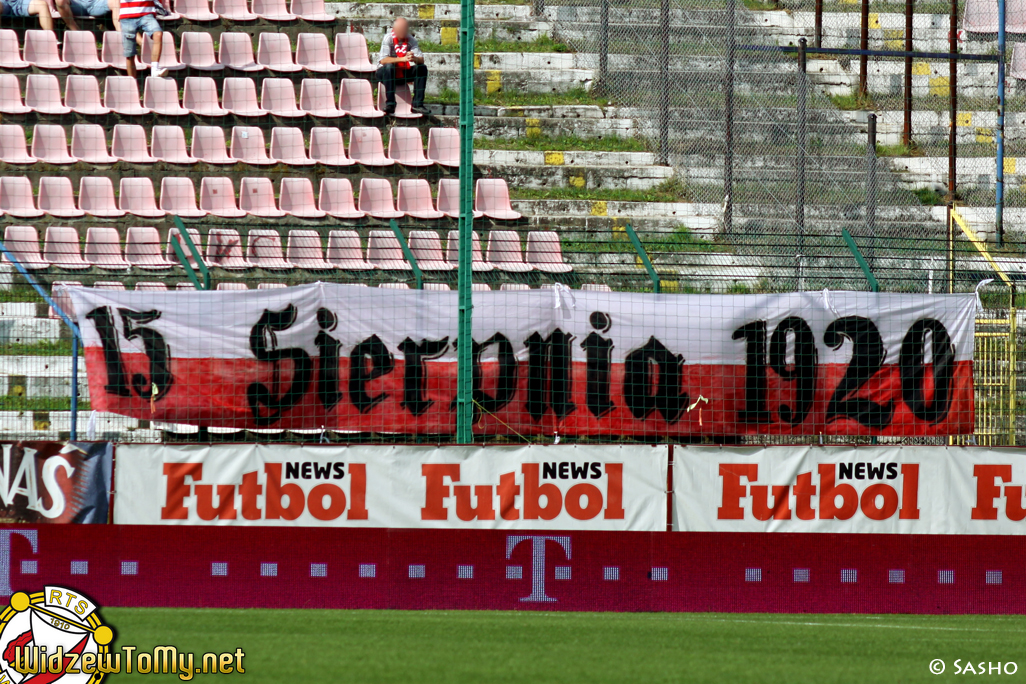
[673, 446, 1026, 534]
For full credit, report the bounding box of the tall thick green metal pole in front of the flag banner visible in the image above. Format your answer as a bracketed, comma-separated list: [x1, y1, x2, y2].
[456, 0, 474, 444]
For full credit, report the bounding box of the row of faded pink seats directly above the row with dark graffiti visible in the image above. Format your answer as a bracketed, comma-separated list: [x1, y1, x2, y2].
[0, 175, 521, 220]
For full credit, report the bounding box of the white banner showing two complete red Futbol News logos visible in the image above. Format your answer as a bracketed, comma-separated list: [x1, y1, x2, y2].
[114, 444, 668, 531]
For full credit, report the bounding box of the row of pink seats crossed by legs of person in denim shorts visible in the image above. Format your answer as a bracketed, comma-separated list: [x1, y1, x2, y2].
[0, 29, 377, 74]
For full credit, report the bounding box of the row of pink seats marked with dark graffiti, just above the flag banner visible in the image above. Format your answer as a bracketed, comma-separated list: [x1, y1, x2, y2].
[4, 226, 573, 273]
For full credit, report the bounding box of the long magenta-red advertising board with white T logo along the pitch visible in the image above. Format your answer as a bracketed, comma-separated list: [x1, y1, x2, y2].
[0, 525, 1026, 615]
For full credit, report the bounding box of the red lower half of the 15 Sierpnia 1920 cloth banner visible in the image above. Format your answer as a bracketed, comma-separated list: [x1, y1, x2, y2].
[85, 347, 975, 437]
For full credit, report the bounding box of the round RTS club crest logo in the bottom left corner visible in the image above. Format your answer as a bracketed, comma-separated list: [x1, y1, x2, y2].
[0, 586, 114, 684]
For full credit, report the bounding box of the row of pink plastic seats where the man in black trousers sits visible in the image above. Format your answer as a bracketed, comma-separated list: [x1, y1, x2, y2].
[0, 74, 410, 119]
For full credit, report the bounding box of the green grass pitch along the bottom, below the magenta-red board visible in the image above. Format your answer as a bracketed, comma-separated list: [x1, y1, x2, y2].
[104, 608, 1026, 684]
